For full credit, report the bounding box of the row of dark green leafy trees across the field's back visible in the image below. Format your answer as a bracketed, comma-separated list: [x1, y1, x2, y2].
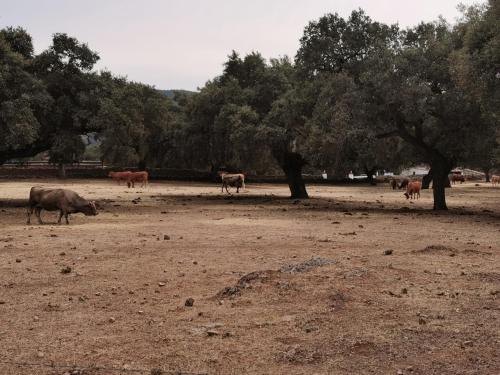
[0, 0, 500, 209]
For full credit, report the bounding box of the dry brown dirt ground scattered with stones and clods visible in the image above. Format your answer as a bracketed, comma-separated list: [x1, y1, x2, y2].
[0, 180, 500, 375]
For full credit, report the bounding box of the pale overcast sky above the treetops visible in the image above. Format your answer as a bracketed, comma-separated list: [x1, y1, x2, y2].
[0, 0, 481, 90]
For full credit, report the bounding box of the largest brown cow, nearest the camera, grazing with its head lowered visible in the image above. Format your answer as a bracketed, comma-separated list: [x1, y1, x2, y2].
[27, 186, 97, 224]
